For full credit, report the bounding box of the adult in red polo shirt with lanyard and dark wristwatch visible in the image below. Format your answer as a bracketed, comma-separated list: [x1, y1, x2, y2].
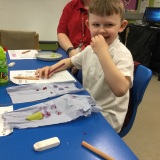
[57, 0, 92, 57]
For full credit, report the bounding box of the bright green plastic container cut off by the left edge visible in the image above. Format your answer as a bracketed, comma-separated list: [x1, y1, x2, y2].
[0, 46, 9, 86]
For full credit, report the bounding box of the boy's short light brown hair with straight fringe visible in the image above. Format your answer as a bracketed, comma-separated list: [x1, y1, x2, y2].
[89, 0, 125, 20]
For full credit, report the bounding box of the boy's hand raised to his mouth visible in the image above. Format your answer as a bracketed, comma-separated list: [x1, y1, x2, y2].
[91, 35, 108, 55]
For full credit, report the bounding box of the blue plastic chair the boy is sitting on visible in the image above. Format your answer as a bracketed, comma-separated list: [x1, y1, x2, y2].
[119, 64, 152, 137]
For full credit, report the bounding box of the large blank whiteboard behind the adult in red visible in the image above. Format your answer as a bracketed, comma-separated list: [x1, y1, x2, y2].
[0, 0, 70, 41]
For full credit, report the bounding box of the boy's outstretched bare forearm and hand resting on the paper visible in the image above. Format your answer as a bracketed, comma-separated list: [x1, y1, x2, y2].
[35, 58, 73, 79]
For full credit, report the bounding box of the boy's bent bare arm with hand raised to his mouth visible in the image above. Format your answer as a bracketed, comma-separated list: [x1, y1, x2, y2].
[91, 35, 131, 97]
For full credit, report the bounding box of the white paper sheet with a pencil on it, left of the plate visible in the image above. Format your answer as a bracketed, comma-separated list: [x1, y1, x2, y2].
[8, 50, 38, 60]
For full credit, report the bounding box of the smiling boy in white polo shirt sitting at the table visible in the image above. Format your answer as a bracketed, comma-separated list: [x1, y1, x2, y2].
[36, 0, 134, 132]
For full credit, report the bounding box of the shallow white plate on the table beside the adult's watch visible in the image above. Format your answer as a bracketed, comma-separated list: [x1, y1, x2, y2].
[35, 51, 62, 61]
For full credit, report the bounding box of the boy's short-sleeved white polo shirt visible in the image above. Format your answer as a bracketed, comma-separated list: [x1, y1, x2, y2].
[71, 38, 134, 132]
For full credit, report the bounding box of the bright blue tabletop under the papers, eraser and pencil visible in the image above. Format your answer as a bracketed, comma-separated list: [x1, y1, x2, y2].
[0, 49, 138, 160]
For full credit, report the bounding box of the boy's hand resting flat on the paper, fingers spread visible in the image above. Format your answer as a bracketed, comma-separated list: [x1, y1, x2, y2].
[35, 66, 52, 79]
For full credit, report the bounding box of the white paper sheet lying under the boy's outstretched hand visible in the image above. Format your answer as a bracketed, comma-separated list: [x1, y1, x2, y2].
[10, 70, 76, 84]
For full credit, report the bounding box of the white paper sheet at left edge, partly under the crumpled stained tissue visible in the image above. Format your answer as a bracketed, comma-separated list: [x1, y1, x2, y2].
[0, 106, 13, 136]
